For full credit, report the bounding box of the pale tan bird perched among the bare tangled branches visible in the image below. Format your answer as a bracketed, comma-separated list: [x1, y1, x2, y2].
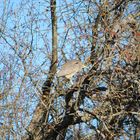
[57, 60, 86, 80]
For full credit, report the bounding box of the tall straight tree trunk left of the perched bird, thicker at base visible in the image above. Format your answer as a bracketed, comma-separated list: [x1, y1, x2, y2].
[25, 0, 58, 140]
